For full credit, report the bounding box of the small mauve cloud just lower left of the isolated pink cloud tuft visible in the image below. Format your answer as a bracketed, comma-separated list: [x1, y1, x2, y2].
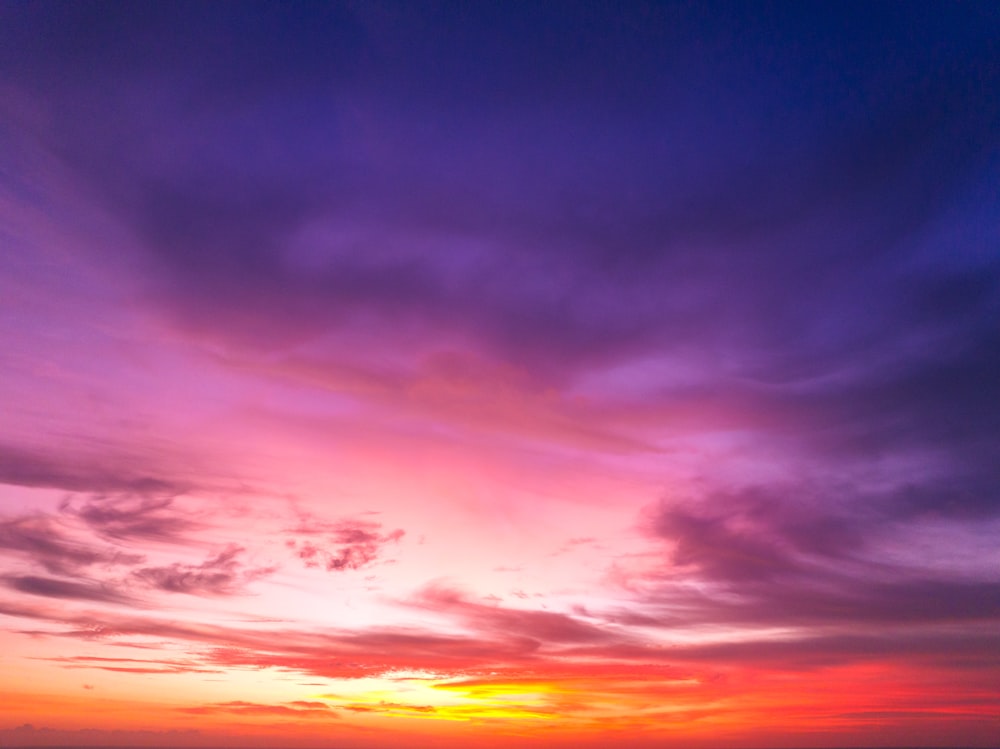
[132, 544, 277, 596]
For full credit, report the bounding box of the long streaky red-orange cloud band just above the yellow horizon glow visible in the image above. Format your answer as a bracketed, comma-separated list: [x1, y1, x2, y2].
[0, 568, 1000, 714]
